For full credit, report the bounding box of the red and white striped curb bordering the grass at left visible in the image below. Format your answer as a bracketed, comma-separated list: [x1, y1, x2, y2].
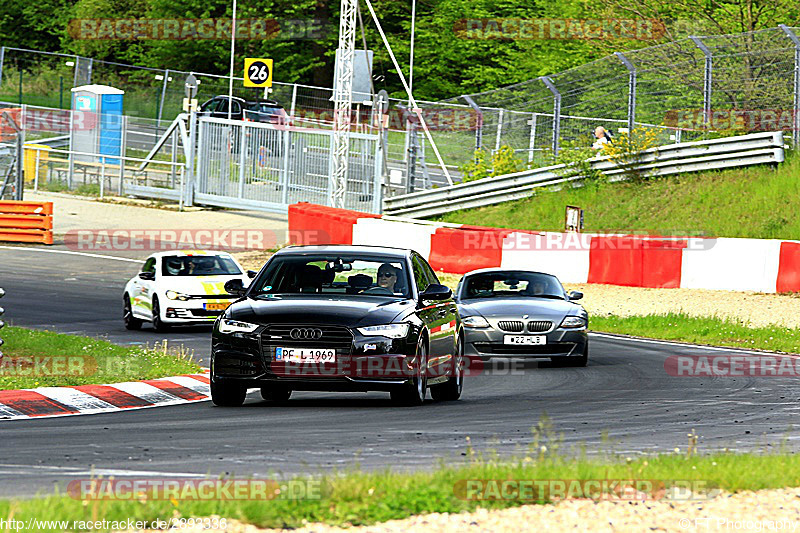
[0, 374, 211, 420]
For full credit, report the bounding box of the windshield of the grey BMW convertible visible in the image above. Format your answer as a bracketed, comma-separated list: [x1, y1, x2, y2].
[461, 272, 566, 300]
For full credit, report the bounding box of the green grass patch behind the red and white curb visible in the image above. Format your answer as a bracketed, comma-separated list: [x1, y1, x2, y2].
[0, 326, 200, 390]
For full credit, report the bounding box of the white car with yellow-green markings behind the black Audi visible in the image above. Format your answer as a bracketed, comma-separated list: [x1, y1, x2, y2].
[122, 250, 256, 331]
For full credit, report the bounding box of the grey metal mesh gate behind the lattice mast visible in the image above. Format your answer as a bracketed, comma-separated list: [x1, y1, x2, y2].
[194, 117, 383, 213]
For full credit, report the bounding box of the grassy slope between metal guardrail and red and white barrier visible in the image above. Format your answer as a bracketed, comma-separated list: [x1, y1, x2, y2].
[440, 151, 800, 239]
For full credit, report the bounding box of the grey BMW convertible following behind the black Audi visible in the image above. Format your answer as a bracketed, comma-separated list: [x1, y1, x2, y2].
[456, 268, 589, 366]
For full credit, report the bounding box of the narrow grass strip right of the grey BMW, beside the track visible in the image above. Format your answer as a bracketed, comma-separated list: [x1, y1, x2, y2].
[589, 313, 800, 353]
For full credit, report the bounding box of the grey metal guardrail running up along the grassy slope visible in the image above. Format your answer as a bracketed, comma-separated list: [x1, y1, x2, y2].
[383, 131, 784, 218]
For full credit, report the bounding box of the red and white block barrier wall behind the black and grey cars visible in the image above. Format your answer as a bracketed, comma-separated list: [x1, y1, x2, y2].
[289, 202, 800, 293]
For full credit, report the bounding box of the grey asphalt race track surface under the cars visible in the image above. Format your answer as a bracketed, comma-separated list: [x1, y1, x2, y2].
[0, 248, 800, 497]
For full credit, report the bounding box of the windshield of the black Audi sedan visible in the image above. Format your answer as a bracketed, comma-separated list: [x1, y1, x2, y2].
[250, 255, 410, 298]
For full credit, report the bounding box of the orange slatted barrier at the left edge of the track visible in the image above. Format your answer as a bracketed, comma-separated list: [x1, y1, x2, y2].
[0, 201, 53, 244]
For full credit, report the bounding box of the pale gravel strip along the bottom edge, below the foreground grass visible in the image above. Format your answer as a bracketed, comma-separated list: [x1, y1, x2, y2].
[130, 488, 800, 533]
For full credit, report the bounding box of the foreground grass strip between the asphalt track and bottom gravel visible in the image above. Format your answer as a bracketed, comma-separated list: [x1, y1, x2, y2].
[0, 446, 800, 528]
